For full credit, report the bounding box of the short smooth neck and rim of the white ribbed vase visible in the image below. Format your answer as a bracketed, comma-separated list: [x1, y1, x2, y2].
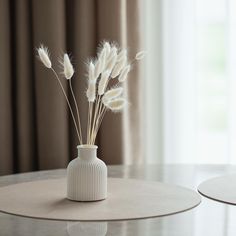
[77, 145, 97, 161]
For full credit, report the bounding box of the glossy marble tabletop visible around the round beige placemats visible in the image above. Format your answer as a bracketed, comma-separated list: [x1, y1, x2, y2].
[0, 164, 236, 236]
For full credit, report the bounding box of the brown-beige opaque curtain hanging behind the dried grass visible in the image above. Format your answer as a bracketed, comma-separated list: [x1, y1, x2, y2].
[0, 0, 143, 175]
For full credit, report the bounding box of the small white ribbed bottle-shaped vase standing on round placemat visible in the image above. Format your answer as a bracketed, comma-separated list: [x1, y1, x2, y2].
[67, 145, 107, 201]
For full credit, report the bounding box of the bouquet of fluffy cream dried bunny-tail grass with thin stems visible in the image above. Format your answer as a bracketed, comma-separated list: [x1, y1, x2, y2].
[37, 42, 145, 145]
